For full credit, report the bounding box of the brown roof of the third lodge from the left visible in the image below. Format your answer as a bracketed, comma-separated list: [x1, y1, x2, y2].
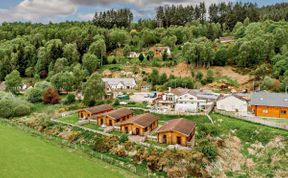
[121, 113, 159, 128]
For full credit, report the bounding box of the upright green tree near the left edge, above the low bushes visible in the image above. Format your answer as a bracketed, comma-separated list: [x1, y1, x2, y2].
[5, 70, 22, 94]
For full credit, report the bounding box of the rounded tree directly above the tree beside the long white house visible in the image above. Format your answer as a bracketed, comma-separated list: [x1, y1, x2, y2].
[83, 53, 100, 74]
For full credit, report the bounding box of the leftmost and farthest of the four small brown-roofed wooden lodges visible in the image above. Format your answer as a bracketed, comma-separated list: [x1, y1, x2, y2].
[78, 104, 113, 119]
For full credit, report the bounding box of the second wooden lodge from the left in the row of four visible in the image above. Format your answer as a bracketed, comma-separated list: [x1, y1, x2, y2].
[97, 108, 133, 127]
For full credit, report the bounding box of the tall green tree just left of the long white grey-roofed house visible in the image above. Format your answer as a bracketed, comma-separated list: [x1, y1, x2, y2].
[83, 73, 105, 105]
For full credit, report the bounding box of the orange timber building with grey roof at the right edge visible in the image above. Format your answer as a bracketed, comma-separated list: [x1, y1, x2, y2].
[250, 92, 288, 118]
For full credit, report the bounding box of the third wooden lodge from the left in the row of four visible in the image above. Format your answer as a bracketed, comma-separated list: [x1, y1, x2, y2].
[120, 113, 159, 136]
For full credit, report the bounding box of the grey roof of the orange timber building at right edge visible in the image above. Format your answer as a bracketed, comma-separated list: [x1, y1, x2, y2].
[250, 92, 288, 107]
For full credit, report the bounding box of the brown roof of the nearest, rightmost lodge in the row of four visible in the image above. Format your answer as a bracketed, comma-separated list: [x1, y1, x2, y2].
[157, 118, 196, 136]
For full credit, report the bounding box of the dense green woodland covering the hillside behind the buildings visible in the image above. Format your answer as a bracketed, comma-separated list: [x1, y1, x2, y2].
[0, 3, 288, 105]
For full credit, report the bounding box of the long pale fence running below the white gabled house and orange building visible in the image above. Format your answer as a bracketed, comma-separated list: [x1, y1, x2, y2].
[215, 110, 288, 130]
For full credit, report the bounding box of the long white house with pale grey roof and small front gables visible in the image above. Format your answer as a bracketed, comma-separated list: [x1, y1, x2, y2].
[102, 78, 136, 91]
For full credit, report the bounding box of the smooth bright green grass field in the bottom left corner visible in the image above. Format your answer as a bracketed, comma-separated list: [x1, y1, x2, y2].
[0, 123, 136, 178]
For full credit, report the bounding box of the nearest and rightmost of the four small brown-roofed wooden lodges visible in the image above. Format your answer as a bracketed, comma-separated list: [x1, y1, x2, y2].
[157, 119, 196, 146]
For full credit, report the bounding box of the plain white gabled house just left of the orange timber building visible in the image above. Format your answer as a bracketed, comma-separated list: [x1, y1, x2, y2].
[216, 95, 248, 113]
